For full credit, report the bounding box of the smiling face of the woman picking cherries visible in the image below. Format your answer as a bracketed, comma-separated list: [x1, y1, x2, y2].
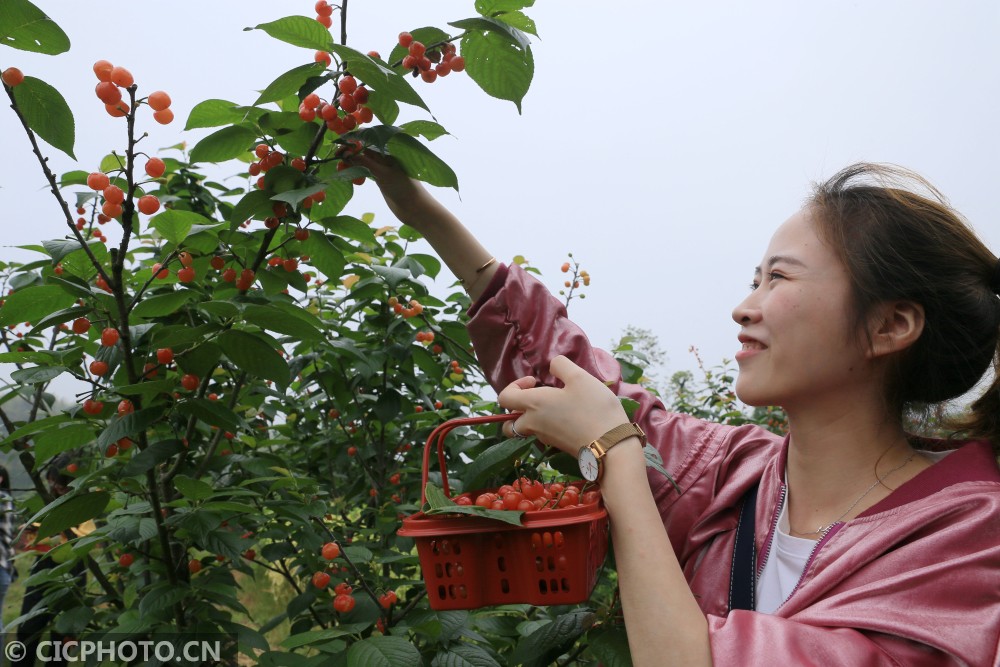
[733, 209, 870, 410]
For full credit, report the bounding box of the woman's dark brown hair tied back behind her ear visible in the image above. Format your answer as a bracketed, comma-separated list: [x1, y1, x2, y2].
[808, 163, 1000, 452]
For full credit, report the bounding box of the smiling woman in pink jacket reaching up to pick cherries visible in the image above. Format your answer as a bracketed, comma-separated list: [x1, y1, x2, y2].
[359, 154, 1000, 666]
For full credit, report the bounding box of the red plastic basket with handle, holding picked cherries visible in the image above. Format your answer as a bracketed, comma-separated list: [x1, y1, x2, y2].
[397, 414, 608, 610]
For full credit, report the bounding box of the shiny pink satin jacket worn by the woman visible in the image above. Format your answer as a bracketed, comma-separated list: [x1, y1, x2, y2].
[469, 266, 1000, 667]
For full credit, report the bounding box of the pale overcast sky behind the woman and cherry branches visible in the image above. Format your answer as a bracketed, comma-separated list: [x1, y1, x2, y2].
[0, 0, 1000, 402]
